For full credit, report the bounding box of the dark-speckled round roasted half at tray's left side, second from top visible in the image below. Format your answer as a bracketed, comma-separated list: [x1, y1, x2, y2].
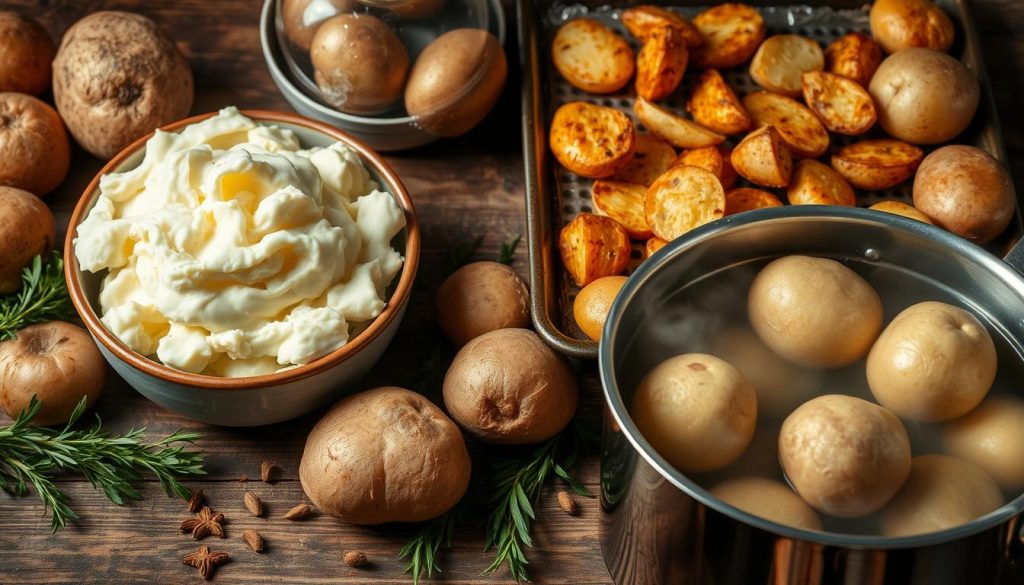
[549, 101, 636, 178]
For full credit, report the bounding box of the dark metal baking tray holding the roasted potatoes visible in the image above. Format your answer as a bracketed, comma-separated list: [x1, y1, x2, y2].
[516, 0, 1024, 358]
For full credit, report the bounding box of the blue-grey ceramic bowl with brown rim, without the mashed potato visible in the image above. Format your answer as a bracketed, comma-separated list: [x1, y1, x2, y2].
[63, 111, 420, 426]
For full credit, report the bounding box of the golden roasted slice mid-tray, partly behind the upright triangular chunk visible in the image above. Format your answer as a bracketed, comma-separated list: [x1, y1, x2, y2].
[740, 91, 828, 157]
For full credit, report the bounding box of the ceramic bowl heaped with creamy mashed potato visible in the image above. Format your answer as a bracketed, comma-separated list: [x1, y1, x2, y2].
[65, 108, 420, 426]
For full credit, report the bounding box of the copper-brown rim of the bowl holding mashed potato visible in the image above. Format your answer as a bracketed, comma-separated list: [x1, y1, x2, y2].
[63, 110, 420, 390]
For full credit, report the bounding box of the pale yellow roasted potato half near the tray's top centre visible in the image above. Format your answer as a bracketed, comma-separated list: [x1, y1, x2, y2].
[751, 35, 825, 97]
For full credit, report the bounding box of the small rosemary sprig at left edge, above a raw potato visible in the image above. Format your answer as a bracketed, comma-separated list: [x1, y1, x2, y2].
[0, 252, 75, 341]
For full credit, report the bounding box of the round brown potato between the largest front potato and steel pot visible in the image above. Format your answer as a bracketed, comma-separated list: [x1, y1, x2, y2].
[444, 329, 579, 445]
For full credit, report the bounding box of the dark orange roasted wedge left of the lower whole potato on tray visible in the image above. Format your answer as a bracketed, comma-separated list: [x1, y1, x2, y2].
[831, 138, 925, 191]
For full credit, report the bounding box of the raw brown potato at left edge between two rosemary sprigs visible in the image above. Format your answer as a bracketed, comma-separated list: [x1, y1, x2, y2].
[0, 321, 106, 426]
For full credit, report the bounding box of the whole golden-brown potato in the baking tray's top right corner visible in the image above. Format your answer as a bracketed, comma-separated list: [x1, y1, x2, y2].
[870, 0, 956, 53]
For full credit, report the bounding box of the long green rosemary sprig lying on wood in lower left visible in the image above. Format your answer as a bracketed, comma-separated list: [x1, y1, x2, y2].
[0, 396, 206, 532]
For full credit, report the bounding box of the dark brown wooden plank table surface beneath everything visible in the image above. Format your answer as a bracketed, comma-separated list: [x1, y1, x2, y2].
[0, 0, 1024, 585]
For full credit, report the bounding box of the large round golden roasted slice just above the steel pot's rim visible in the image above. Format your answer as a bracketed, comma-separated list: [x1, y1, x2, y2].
[644, 166, 725, 240]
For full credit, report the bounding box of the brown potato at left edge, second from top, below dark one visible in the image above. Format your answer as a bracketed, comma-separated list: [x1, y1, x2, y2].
[0, 93, 71, 197]
